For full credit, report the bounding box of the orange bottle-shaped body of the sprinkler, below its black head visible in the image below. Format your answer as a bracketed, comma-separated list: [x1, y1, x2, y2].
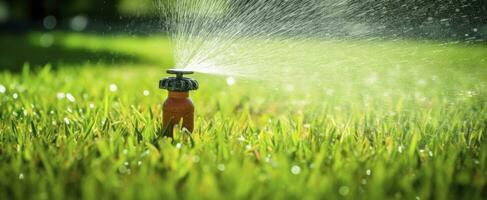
[162, 91, 194, 138]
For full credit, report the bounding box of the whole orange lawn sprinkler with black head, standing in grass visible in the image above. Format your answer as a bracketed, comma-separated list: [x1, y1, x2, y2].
[159, 69, 199, 138]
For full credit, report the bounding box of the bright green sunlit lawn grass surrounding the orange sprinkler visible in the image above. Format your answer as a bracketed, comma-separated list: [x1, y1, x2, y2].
[0, 33, 487, 199]
